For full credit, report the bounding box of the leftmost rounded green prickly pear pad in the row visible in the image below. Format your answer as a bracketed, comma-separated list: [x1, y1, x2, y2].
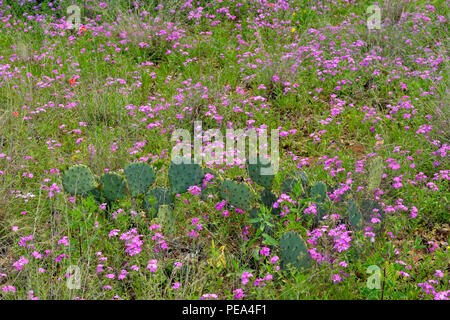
[62, 164, 97, 196]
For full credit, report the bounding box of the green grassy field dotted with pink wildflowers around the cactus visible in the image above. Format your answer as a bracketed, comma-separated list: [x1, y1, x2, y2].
[0, 0, 450, 300]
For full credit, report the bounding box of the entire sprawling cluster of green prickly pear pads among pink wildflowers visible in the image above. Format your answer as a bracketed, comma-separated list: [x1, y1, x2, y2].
[63, 158, 342, 278]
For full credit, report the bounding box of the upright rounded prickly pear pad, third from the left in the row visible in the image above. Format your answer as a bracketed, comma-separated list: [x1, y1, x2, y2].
[123, 161, 155, 197]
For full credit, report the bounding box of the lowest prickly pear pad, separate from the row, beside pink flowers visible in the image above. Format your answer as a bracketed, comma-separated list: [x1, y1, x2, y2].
[280, 231, 311, 271]
